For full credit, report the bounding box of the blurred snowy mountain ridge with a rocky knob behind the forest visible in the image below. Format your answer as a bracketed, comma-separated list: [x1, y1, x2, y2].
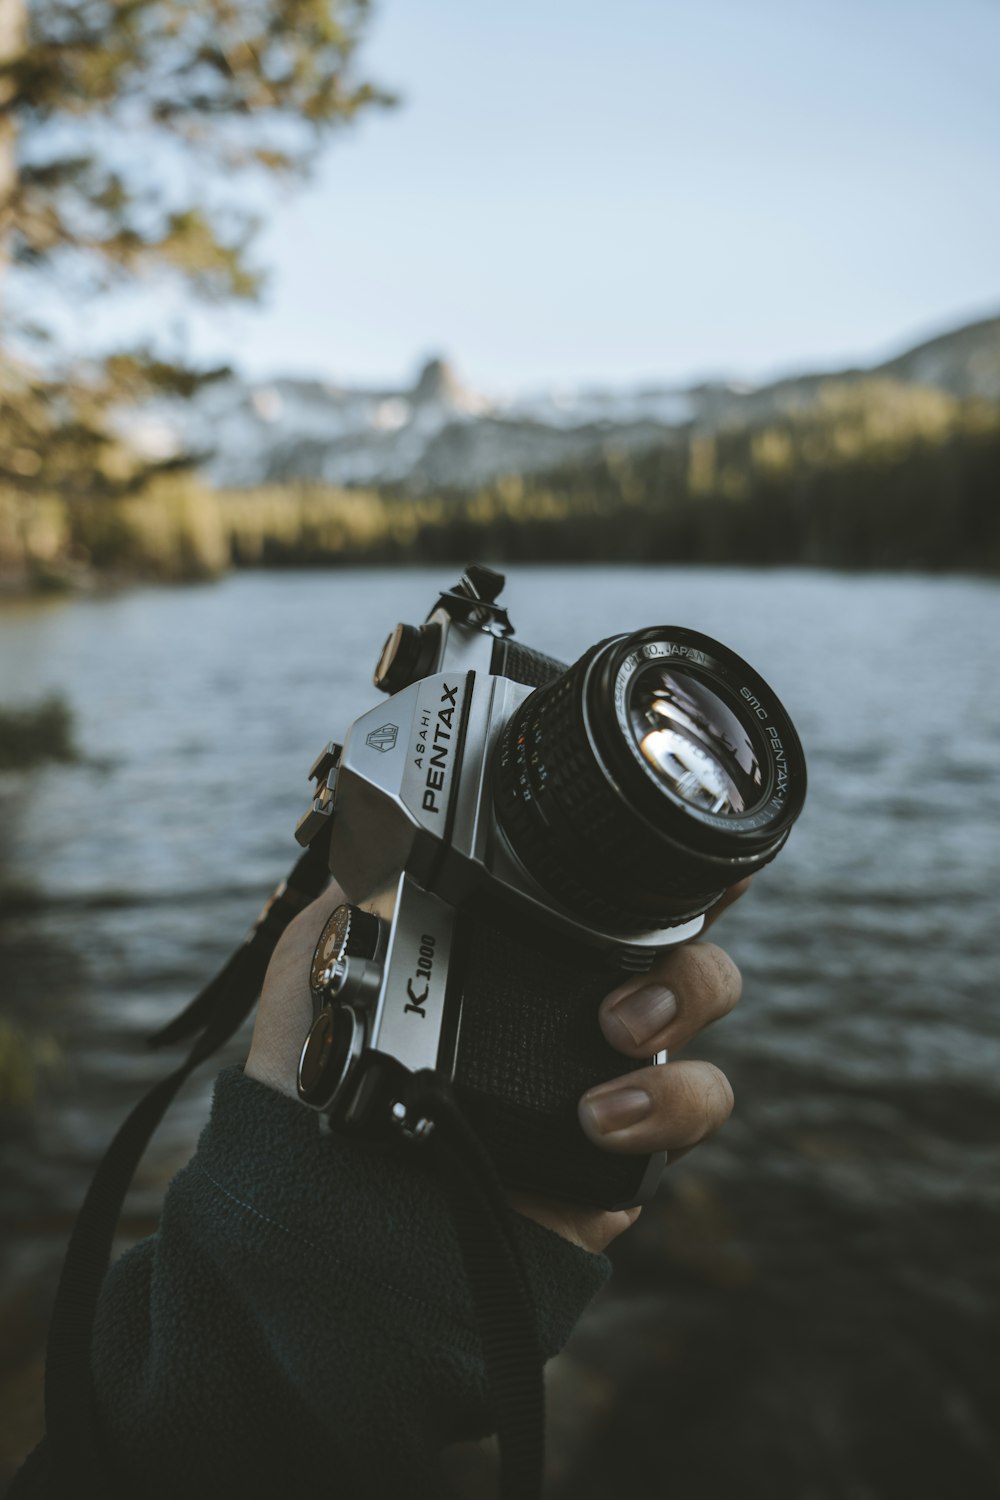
[130, 317, 1000, 494]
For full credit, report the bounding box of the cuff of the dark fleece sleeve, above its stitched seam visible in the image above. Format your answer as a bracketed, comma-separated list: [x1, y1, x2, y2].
[187, 1068, 610, 1359]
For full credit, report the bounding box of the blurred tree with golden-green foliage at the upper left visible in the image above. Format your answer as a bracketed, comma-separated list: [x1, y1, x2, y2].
[0, 0, 391, 510]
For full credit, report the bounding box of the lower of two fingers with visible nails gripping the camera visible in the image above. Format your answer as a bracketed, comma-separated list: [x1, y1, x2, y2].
[579, 1062, 733, 1152]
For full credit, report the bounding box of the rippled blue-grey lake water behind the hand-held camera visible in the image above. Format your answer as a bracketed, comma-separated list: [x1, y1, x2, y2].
[0, 569, 1000, 1500]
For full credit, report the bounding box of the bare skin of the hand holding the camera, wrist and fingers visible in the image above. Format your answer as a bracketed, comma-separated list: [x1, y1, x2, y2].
[243, 881, 750, 1253]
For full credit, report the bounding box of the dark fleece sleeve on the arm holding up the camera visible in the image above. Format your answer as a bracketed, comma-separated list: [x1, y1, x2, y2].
[35, 1068, 609, 1500]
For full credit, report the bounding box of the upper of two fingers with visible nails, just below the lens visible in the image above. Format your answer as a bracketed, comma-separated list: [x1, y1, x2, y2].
[598, 942, 742, 1058]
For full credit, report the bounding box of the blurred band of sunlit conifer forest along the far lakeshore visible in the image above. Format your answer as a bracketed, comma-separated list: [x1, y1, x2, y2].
[0, 380, 1000, 584]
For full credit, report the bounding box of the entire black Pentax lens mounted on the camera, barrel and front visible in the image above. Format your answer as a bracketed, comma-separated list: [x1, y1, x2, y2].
[493, 626, 805, 933]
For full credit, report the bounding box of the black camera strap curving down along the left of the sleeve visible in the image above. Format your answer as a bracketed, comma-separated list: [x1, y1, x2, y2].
[38, 834, 330, 1496]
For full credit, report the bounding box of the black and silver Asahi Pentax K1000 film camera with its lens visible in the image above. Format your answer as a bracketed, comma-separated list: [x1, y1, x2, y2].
[289, 567, 805, 1208]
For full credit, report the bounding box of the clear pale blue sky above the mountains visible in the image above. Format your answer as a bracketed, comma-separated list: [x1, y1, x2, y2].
[74, 0, 1000, 395]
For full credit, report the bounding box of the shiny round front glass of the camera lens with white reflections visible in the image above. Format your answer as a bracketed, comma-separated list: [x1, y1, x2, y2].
[628, 663, 763, 816]
